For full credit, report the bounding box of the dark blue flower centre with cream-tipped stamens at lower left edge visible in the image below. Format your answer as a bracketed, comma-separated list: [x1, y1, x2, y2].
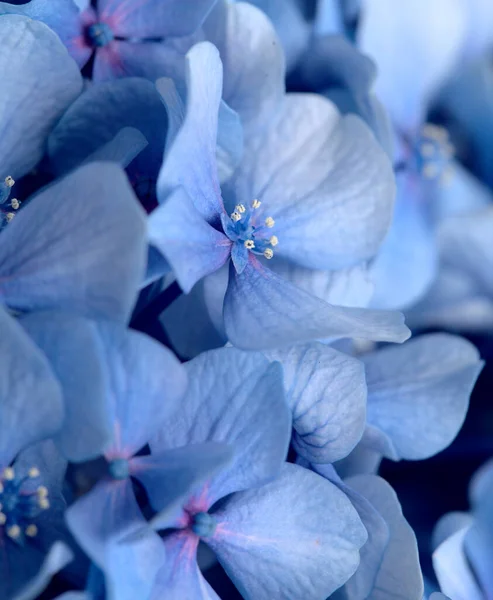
[0, 467, 50, 543]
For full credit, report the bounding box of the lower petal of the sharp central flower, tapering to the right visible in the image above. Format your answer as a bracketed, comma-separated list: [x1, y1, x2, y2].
[224, 258, 409, 350]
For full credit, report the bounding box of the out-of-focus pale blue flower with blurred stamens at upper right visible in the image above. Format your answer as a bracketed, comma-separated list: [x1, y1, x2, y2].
[357, 0, 492, 308]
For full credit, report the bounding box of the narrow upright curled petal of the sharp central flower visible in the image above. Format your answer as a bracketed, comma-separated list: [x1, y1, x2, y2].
[158, 42, 223, 222]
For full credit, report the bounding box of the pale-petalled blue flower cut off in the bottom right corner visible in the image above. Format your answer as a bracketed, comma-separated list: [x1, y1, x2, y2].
[433, 461, 493, 600]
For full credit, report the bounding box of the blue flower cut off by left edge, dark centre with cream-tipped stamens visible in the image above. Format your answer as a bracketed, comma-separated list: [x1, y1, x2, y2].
[0, 309, 76, 600]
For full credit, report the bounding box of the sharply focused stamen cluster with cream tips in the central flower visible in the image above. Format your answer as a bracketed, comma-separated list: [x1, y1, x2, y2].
[221, 200, 279, 260]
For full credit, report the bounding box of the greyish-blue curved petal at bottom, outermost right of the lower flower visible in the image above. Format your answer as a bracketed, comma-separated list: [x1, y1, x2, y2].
[345, 475, 424, 600]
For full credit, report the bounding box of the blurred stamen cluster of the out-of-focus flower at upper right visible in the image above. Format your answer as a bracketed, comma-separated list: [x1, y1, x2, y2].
[415, 123, 454, 184]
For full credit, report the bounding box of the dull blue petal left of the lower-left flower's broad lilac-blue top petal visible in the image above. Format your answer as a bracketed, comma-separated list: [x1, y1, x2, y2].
[20, 312, 113, 462]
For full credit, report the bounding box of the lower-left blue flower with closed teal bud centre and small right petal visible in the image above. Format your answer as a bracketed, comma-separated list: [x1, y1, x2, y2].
[47, 322, 230, 599]
